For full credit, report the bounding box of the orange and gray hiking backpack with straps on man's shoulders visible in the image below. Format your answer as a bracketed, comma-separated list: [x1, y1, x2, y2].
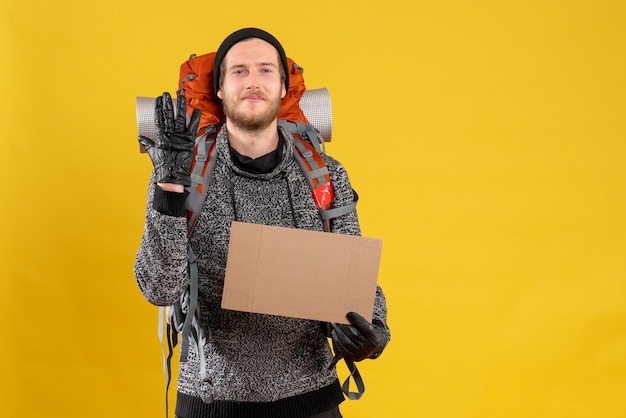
[150, 53, 365, 416]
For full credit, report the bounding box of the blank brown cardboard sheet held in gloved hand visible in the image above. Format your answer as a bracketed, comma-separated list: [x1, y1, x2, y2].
[222, 222, 383, 323]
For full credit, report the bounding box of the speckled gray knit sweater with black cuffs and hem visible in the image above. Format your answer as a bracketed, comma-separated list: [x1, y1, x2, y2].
[135, 127, 387, 418]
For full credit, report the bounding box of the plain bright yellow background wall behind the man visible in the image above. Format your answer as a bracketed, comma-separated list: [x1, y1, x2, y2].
[0, 0, 626, 418]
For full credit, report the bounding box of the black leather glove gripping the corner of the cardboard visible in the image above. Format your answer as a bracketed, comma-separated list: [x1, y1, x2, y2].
[330, 312, 387, 361]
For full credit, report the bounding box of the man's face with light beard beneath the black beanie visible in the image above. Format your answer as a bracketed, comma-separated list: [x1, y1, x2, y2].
[217, 38, 286, 131]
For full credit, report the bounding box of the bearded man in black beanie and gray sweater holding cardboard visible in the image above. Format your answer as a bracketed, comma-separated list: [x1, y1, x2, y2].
[135, 28, 390, 418]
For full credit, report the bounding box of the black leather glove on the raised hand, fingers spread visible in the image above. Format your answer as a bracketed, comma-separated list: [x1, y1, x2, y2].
[139, 93, 200, 186]
